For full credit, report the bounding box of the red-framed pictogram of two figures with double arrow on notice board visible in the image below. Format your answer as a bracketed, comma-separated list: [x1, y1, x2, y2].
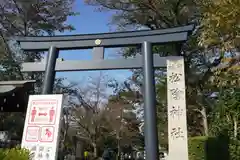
[28, 100, 57, 125]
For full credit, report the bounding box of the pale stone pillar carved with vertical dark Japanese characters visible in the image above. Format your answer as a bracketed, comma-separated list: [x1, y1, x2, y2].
[167, 57, 188, 160]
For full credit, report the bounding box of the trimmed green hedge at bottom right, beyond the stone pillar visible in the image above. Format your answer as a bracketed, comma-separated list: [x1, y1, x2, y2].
[189, 136, 240, 160]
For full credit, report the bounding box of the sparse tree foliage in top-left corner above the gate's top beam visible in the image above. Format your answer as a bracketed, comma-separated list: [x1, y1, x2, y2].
[0, 0, 75, 37]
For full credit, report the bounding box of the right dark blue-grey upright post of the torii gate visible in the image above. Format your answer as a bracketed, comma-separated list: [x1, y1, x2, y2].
[142, 42, 159, 160]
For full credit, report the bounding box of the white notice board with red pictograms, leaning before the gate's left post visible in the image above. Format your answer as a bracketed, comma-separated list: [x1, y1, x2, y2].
[21, 95, 63, 160]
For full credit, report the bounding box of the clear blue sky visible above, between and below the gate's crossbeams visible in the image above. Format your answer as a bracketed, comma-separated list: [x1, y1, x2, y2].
[57, 0, 131, 82]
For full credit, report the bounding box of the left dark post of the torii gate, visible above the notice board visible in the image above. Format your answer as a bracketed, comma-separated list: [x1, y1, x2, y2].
[42, 46, 59, 94]
